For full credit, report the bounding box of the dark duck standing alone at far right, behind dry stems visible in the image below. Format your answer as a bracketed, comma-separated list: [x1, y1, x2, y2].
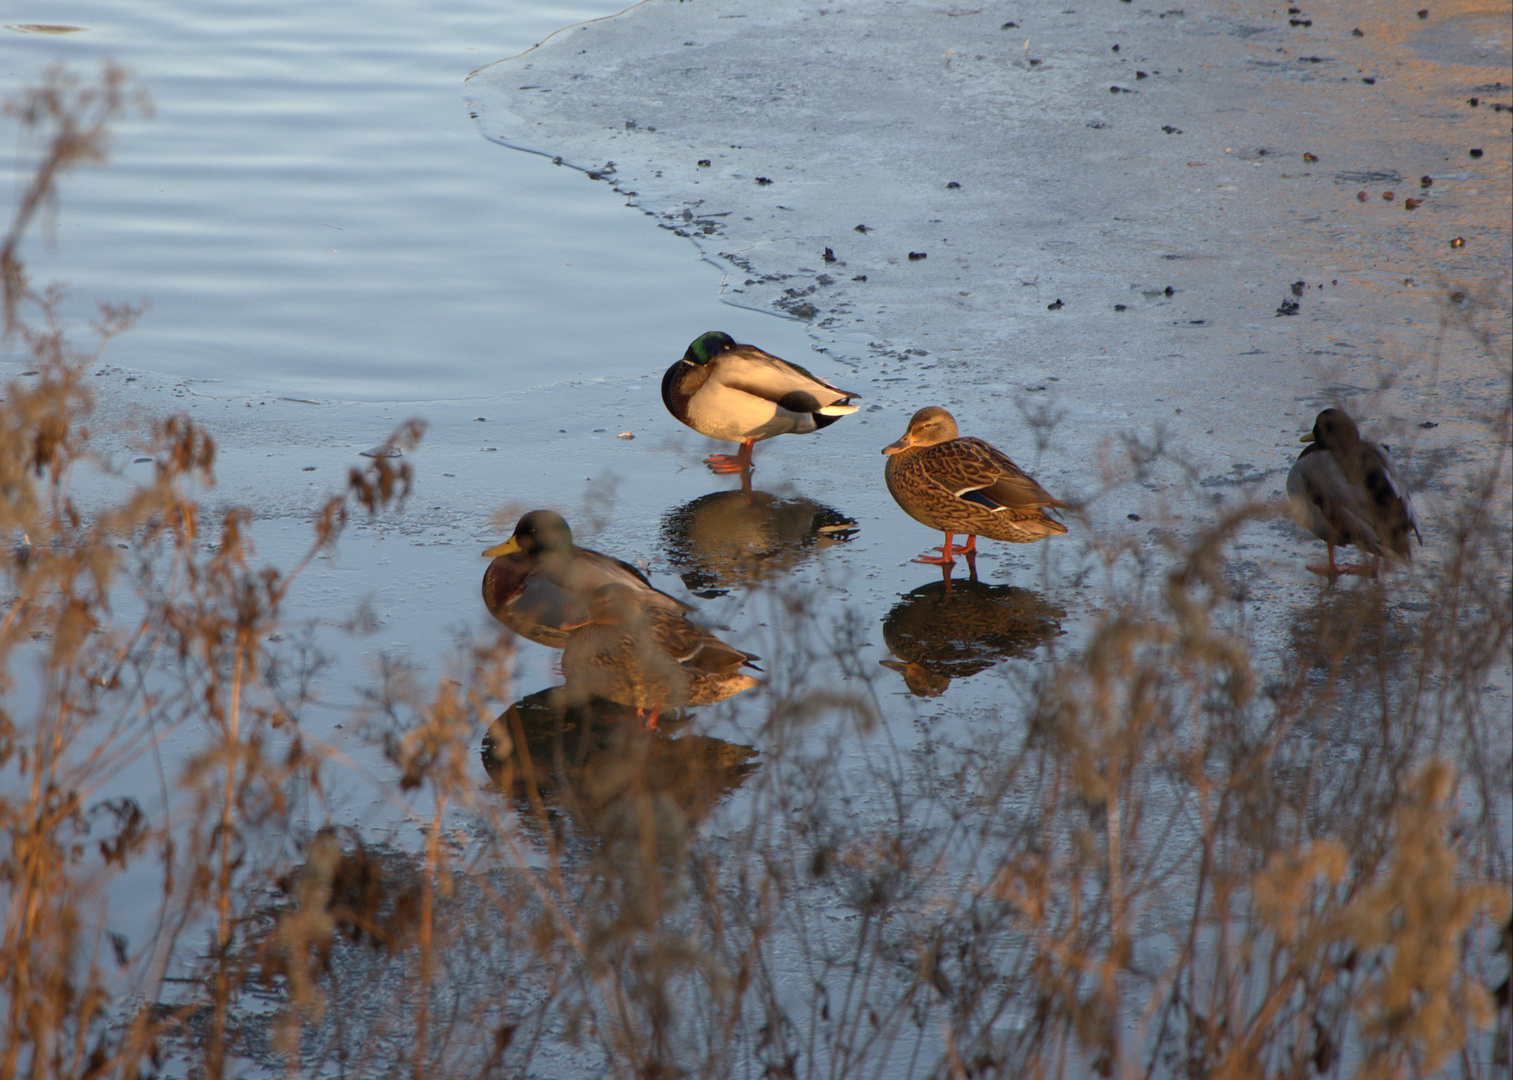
[1288, 408, 1424, 578]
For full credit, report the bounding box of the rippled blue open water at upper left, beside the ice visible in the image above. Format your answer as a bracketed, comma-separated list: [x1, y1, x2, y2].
[0, 0, 817, 401]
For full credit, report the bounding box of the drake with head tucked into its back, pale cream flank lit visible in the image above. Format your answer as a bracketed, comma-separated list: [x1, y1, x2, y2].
[663, 330, 859, 473]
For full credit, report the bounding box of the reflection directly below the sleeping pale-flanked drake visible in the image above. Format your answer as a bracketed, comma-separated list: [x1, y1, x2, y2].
[663, 492, 856, 599]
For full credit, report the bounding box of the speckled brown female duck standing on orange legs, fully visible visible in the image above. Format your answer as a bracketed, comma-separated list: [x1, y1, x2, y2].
[882, 405, 1070, 579]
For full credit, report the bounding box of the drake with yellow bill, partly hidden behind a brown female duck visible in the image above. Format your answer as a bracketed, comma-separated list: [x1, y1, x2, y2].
[483, 510, 693, 649]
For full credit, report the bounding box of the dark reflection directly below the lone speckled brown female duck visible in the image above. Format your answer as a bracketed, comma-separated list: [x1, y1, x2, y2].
[881, 581, 1067, 697]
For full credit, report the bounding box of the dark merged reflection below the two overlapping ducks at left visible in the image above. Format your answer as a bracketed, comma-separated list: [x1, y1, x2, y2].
[481, 687, 758, 832]
